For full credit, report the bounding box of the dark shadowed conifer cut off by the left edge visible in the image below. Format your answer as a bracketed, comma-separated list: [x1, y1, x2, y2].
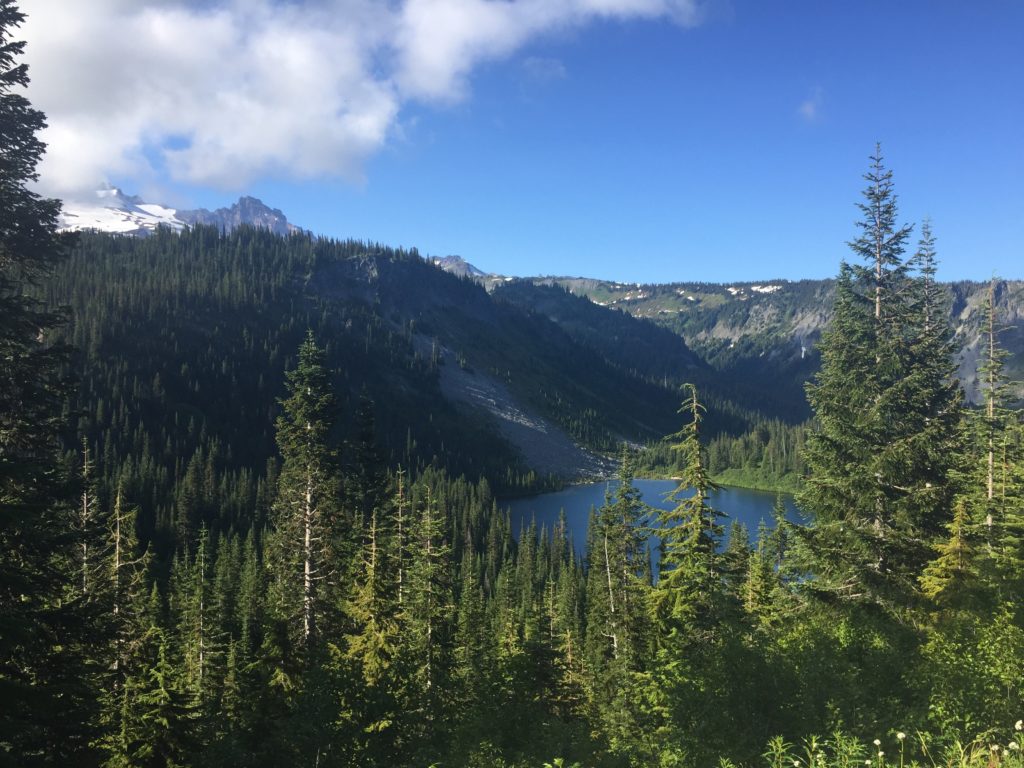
[0, 0, 88, 765]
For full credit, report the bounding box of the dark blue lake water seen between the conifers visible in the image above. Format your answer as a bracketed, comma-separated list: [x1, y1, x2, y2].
[500, 480, 802, 554]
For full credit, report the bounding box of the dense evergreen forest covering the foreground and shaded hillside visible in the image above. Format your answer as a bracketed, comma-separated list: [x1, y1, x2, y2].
[0, 6, 1024, 768]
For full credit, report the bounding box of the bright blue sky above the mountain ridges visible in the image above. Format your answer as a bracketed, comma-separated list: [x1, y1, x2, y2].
[26, 0, 1024, 282]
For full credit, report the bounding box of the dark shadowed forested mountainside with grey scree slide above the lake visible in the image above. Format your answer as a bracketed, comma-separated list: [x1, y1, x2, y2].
[47, 224, 716, 493]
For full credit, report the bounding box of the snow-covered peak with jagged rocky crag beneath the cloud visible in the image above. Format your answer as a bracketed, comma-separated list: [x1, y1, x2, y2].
[60, 187, 300, 234]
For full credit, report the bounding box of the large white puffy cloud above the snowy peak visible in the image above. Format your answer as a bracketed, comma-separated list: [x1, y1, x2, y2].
[18, 0, 702, 197]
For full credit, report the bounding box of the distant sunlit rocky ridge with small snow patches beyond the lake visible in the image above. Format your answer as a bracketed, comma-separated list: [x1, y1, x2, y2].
[448, 264, 1024, 409]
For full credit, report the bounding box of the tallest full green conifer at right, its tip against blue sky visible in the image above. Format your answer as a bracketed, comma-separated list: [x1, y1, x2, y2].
[799, 152, 961, 617]
